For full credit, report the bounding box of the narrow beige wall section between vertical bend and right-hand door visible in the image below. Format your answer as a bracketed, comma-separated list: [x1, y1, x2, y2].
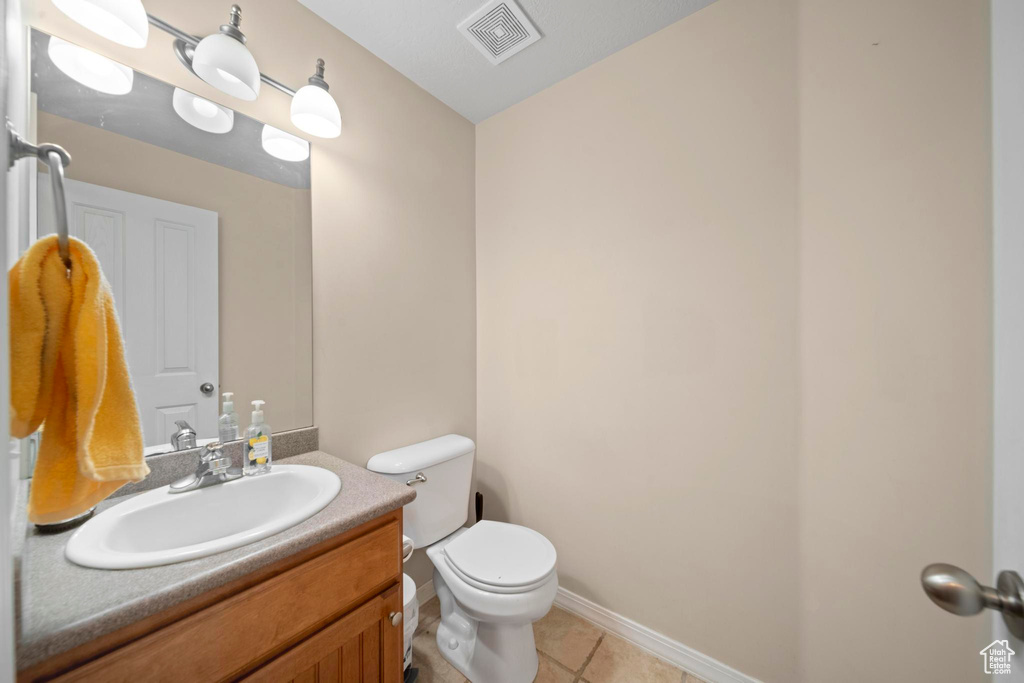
[800, 0, 991, 681]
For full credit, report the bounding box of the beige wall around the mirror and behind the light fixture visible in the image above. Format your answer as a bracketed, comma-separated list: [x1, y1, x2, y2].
[29, 0, 476, 581]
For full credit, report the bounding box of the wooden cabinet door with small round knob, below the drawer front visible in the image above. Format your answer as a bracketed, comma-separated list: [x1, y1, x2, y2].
[245, 585, 402, 683]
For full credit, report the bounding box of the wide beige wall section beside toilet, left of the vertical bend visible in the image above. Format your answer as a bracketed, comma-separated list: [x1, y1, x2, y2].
[476, 0, 799, 681]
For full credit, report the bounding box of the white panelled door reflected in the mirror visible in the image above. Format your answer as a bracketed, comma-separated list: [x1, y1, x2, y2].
[37, 175, 218, 446]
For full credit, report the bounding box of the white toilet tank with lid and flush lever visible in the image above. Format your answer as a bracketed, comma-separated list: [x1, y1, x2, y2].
[367, 434, 476, 548]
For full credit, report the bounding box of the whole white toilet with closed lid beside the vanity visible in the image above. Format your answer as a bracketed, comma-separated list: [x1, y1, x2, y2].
[367, 434, 558, 683]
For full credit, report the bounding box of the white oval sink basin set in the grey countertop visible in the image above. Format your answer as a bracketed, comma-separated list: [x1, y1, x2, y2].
[65, 465, 341, 569]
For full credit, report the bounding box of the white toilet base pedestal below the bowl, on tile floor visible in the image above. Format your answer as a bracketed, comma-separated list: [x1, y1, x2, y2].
[434, 569, 540, 683]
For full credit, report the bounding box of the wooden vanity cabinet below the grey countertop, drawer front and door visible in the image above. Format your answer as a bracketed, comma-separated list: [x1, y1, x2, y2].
[18, 510, 403, 683]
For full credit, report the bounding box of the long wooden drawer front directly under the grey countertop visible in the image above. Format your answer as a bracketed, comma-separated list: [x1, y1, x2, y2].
[57, 521, 401, 683]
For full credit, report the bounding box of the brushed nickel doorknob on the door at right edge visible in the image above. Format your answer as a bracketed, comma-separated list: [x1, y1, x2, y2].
[921, 562, 1024, 639]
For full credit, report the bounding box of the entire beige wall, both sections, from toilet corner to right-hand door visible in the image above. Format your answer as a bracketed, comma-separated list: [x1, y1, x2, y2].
[477, 0, 991, 682]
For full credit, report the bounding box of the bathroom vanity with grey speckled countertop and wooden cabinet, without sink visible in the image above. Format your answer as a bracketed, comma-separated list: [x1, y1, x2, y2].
[17, 452, 415, 683]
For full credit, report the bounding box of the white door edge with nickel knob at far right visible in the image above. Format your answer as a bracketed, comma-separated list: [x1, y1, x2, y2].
[926, 0, 1024, 681]
